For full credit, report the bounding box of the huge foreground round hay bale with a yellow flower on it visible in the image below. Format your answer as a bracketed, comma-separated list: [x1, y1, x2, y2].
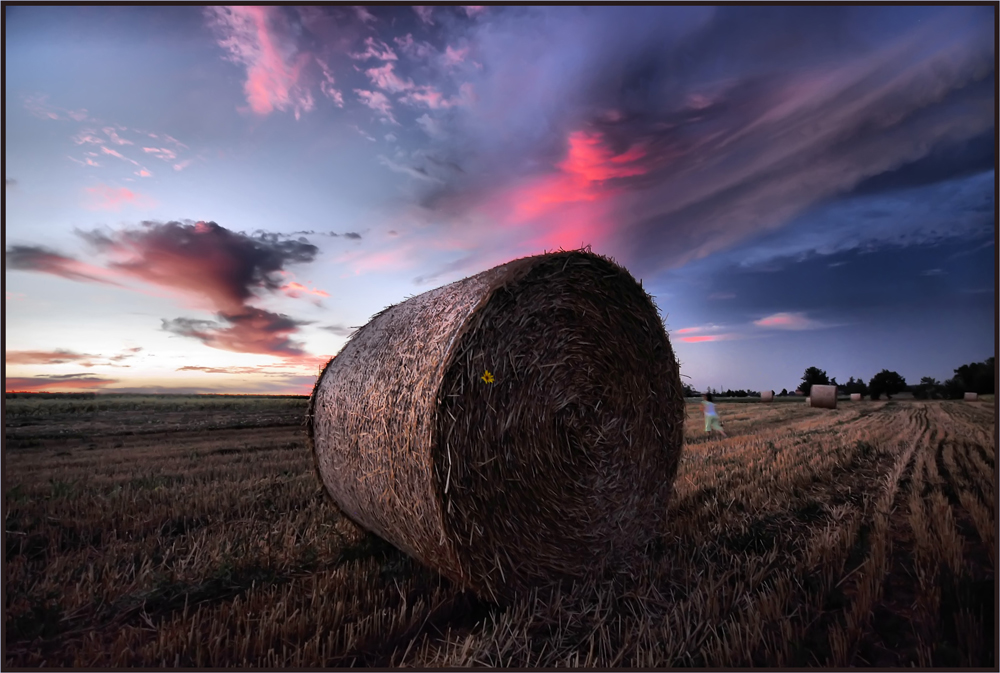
[307, 250, 685, 599]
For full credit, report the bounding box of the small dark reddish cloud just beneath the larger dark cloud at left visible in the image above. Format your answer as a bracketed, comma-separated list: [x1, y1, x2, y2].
[162, 306, 309, 357]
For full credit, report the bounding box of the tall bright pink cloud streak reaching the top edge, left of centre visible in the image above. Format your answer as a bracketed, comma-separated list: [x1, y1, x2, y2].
[209, 5, 314, 119]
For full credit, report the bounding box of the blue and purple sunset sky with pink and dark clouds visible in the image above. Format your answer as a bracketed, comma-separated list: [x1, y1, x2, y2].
[4, 5, 997, 394]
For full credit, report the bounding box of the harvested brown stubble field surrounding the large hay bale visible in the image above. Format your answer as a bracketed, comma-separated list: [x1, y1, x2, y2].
[3, 397, 997, 668]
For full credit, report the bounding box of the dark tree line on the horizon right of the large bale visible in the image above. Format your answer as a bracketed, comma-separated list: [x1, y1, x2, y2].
[684, 356, 996, 400]
